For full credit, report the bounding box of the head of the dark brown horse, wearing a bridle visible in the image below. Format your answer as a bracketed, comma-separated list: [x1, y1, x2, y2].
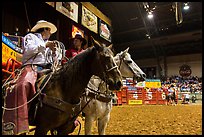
[92, 37, 122, 90]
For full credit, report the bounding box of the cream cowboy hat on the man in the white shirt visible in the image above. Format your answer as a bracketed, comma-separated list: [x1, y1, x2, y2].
[31, 20, 57, 33]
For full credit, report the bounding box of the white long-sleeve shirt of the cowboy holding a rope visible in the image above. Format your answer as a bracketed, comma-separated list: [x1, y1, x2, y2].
[22, 33, 48, 65]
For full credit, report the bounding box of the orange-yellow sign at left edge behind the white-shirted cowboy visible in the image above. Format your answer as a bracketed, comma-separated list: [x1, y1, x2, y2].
[2, 42, 16, 64]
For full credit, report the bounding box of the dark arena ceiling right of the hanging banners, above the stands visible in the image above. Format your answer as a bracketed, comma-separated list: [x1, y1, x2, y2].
[91, 2, 202, 60]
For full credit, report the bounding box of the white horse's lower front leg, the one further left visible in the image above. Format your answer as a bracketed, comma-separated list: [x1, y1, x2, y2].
[84, 115, 94, 135]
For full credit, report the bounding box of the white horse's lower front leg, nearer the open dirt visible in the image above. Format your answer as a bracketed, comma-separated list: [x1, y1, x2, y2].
[98, 113, 110, 135]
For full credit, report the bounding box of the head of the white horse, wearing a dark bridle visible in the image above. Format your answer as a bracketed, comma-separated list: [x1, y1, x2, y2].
[114, 47, 146, 82]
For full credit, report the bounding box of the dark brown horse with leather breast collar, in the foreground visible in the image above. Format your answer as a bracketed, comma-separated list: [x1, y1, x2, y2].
[29, 37, 122, 135]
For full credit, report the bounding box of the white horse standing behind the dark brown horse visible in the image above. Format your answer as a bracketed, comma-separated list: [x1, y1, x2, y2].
[81, 48, 146, 135]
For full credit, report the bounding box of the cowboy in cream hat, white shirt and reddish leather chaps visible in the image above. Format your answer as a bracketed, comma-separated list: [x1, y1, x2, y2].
[3, 20, 57, 134]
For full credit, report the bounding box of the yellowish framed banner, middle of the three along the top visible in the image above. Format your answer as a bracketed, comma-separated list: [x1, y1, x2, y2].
[81, 6, 98, 33]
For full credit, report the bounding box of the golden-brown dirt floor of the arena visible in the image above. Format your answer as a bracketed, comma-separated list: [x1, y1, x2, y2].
[27, 104, 202, 135]
